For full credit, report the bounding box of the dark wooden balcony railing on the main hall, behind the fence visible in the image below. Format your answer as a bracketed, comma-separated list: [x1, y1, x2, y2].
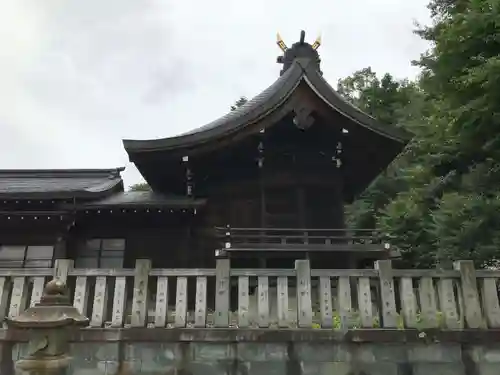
[215, 226, 388, 255]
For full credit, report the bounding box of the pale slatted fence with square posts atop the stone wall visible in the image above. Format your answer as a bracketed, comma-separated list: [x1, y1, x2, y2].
[0, 259, 500, 330]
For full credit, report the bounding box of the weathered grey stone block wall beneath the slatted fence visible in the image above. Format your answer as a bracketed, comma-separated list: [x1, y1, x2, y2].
[8, 341, 500, 375]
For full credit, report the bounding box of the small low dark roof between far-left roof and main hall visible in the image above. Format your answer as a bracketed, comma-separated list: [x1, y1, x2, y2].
[79, 191, 205, 209]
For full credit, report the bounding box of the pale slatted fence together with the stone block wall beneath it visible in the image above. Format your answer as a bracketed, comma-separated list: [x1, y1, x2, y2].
[0, 260, 500, 375]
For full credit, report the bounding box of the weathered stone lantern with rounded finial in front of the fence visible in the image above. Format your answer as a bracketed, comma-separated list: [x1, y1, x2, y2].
[6, 279, 89, 375]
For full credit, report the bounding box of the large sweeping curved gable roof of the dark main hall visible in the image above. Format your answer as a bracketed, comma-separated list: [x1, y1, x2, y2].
[123, 58, 412, 156]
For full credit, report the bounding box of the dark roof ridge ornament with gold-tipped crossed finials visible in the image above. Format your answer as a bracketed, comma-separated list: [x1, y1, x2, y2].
[276, 30, 321, 75]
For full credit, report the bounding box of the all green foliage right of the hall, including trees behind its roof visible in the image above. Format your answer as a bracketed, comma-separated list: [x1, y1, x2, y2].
[346, 0, 500, 267]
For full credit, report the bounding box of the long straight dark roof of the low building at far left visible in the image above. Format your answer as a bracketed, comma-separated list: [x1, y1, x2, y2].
[0, 168, 125, 199]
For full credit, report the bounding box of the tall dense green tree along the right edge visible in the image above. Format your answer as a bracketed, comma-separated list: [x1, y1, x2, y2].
[378, 0, 500, 266]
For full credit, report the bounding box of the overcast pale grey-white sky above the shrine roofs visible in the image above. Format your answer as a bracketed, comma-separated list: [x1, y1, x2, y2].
[0, 0, 429, 185]
